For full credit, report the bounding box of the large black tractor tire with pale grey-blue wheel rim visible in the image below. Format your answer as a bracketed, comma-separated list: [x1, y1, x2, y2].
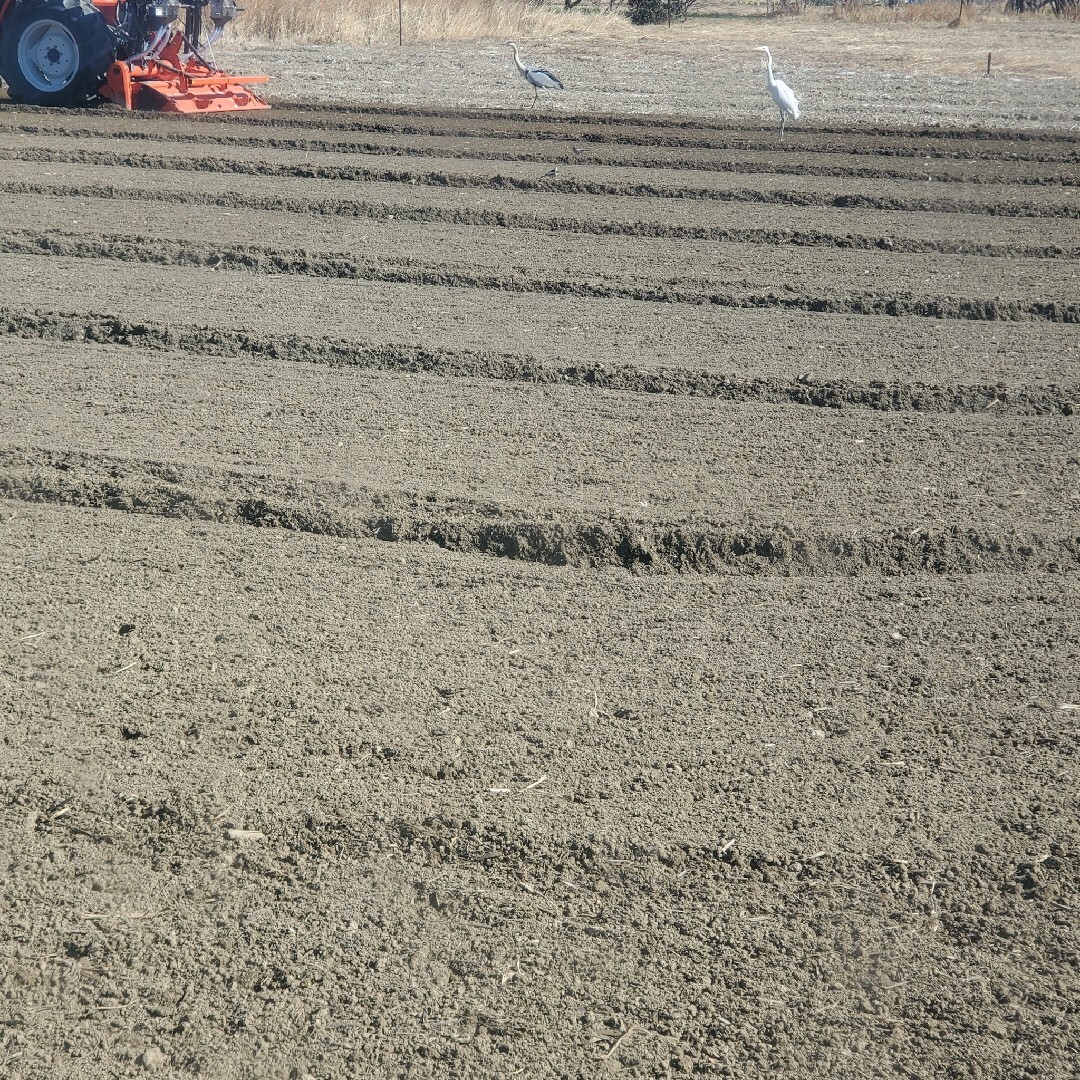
[0, 0, 117, 106]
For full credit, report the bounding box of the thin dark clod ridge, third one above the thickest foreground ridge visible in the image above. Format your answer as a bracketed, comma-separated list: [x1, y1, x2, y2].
[0, 180, 1080, 259]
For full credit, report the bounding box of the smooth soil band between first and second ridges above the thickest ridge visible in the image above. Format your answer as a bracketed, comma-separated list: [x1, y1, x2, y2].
[6, 255, 1080, 390]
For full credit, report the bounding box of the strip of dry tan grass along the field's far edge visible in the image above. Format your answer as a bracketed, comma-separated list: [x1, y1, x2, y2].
[229, 0, 1080, 79]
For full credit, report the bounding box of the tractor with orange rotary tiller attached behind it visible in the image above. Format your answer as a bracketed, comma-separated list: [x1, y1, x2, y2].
[0, 0, 269, 113]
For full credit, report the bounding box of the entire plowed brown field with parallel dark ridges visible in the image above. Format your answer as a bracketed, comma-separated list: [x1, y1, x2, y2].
[0, 105, 1080, 1080]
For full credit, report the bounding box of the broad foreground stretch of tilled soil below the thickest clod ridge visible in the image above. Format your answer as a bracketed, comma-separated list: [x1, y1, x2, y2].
[0, 498, 1077, 1080]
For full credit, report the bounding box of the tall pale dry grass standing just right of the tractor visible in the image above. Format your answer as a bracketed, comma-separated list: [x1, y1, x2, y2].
[230, 0, 626, 45]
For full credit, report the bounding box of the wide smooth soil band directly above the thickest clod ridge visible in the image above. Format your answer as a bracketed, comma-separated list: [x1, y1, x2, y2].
[6, 339, 1078, 536]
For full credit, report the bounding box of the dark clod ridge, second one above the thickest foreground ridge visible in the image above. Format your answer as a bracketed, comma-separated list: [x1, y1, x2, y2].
[6, 230, 1080, 323]
